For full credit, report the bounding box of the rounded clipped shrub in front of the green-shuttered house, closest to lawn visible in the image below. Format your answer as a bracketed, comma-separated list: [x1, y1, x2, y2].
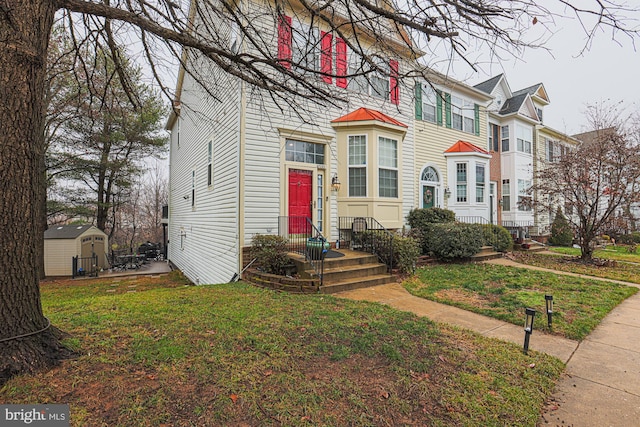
[430, 222, 484, 260]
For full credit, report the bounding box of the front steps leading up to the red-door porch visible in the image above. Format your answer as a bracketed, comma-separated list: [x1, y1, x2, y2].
[289, 249, 396, 294]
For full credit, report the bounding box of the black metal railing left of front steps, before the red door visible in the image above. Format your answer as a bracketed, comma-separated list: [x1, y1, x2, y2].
[278, 216, 329, 286]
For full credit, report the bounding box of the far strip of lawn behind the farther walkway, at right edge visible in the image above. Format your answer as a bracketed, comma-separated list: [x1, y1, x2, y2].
[514, 252, 640, 283]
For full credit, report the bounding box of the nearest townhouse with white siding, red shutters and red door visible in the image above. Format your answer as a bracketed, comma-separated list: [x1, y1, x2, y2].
[167, 1, 416, 283]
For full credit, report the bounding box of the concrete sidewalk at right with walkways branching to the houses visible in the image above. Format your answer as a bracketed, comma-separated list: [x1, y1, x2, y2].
[336, 258, 640, 427]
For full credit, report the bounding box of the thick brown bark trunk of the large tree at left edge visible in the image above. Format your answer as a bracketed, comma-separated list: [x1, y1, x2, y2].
[0, 0, 67, 384]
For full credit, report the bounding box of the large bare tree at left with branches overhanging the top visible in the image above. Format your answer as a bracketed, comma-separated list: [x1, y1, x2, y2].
[0, 0, 638, 383]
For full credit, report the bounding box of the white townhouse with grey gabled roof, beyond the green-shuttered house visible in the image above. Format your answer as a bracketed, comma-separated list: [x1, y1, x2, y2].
[474, 74, 577, 237]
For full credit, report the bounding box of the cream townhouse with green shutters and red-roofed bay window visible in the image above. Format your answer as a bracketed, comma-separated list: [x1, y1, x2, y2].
[413, 72, 497, 222]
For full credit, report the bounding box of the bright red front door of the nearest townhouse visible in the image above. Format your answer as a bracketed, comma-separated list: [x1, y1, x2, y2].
[289, 169, 313, 234]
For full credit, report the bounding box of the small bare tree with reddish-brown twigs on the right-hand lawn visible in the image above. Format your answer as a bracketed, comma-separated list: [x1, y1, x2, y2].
[533, 105, 640, 262]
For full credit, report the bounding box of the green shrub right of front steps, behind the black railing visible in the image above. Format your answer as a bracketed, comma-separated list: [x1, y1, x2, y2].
[362, 230, 420, 273]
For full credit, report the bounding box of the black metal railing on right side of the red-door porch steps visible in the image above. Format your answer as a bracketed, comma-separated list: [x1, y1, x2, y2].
[338, 216, 393, 273]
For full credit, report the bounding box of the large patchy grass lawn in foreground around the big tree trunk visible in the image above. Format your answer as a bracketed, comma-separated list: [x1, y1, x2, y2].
[0, 277, 563, 426]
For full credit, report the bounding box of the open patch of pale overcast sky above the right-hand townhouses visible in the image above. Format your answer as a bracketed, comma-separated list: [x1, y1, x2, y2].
[428, 0, 640, 135]
